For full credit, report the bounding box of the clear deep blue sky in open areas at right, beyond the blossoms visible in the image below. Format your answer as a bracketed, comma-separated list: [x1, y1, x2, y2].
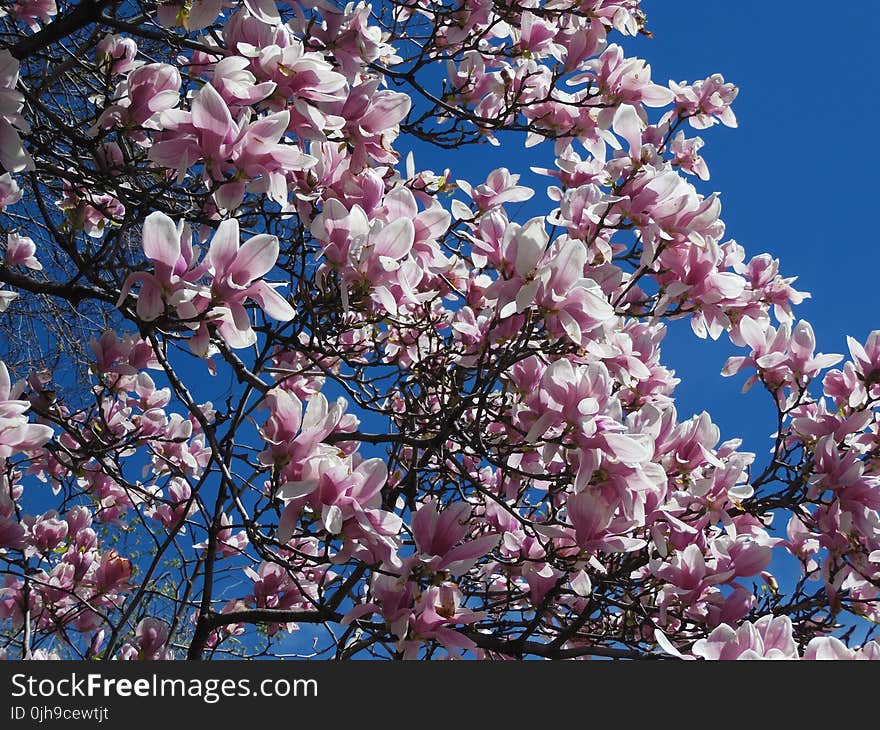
[408, 0, 880, 465]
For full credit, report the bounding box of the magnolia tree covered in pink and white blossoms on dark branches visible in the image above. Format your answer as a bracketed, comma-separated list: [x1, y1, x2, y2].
[0, 0, 880, 659]
